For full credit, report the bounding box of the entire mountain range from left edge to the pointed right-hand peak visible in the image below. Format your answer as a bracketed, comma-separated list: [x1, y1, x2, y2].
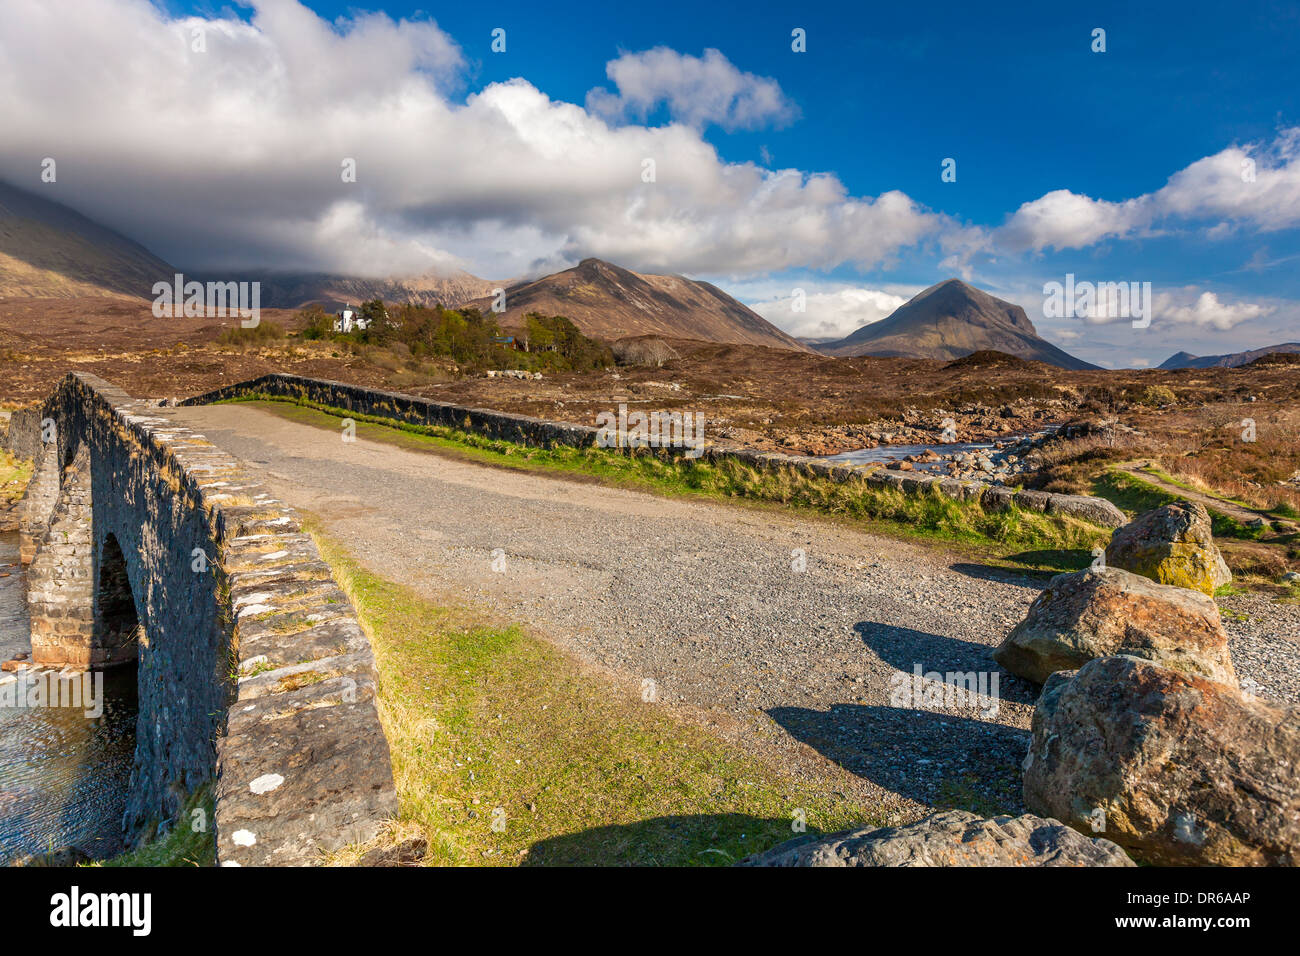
[0, 182, 1128, 369]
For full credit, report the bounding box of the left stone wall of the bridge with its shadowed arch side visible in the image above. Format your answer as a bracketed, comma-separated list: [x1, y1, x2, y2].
[8, 373, 397, 865]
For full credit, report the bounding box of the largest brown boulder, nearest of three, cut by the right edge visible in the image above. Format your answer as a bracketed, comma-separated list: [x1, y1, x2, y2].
[1024, 656, 1300, 866]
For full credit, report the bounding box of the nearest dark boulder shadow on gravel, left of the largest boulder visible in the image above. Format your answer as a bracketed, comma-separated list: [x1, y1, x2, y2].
[767, 704, 1030, 816]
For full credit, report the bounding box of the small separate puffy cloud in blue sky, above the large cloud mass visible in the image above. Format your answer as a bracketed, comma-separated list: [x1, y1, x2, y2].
[586, 47, 798, 130]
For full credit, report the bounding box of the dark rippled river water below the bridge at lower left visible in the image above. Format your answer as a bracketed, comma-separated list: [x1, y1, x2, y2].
[0, 532, 135, 865]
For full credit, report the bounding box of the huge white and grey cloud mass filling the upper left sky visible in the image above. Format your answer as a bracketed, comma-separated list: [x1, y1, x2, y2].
[0, 0, 958, 278]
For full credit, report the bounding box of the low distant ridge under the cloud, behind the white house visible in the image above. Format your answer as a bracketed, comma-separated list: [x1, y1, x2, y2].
[250, 272, 503, 310]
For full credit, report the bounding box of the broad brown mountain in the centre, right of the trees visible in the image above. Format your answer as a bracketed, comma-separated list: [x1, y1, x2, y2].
[468, 259, 810, 351]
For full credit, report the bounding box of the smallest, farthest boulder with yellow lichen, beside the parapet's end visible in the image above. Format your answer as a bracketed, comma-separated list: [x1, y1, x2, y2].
[1106, 501, 1232, 594]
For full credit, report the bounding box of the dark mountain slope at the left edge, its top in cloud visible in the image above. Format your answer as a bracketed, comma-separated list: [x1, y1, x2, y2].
[0, 182, 177, 299]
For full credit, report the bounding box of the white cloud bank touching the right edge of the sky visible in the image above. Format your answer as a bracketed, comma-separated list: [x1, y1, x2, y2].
[995, 127, 1300, 252]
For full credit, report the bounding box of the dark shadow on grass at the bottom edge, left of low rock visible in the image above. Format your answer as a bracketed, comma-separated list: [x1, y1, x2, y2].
[523, 813, 796, 866]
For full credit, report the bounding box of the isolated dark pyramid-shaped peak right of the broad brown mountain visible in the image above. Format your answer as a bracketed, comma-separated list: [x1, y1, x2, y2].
[818, 278, 1097, 369]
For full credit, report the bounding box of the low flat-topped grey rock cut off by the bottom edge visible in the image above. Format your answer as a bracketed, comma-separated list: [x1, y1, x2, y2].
[741, 810, 1134, 866]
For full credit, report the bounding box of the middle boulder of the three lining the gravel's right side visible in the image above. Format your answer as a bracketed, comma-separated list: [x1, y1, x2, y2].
[993, 567, 1238, 687]
